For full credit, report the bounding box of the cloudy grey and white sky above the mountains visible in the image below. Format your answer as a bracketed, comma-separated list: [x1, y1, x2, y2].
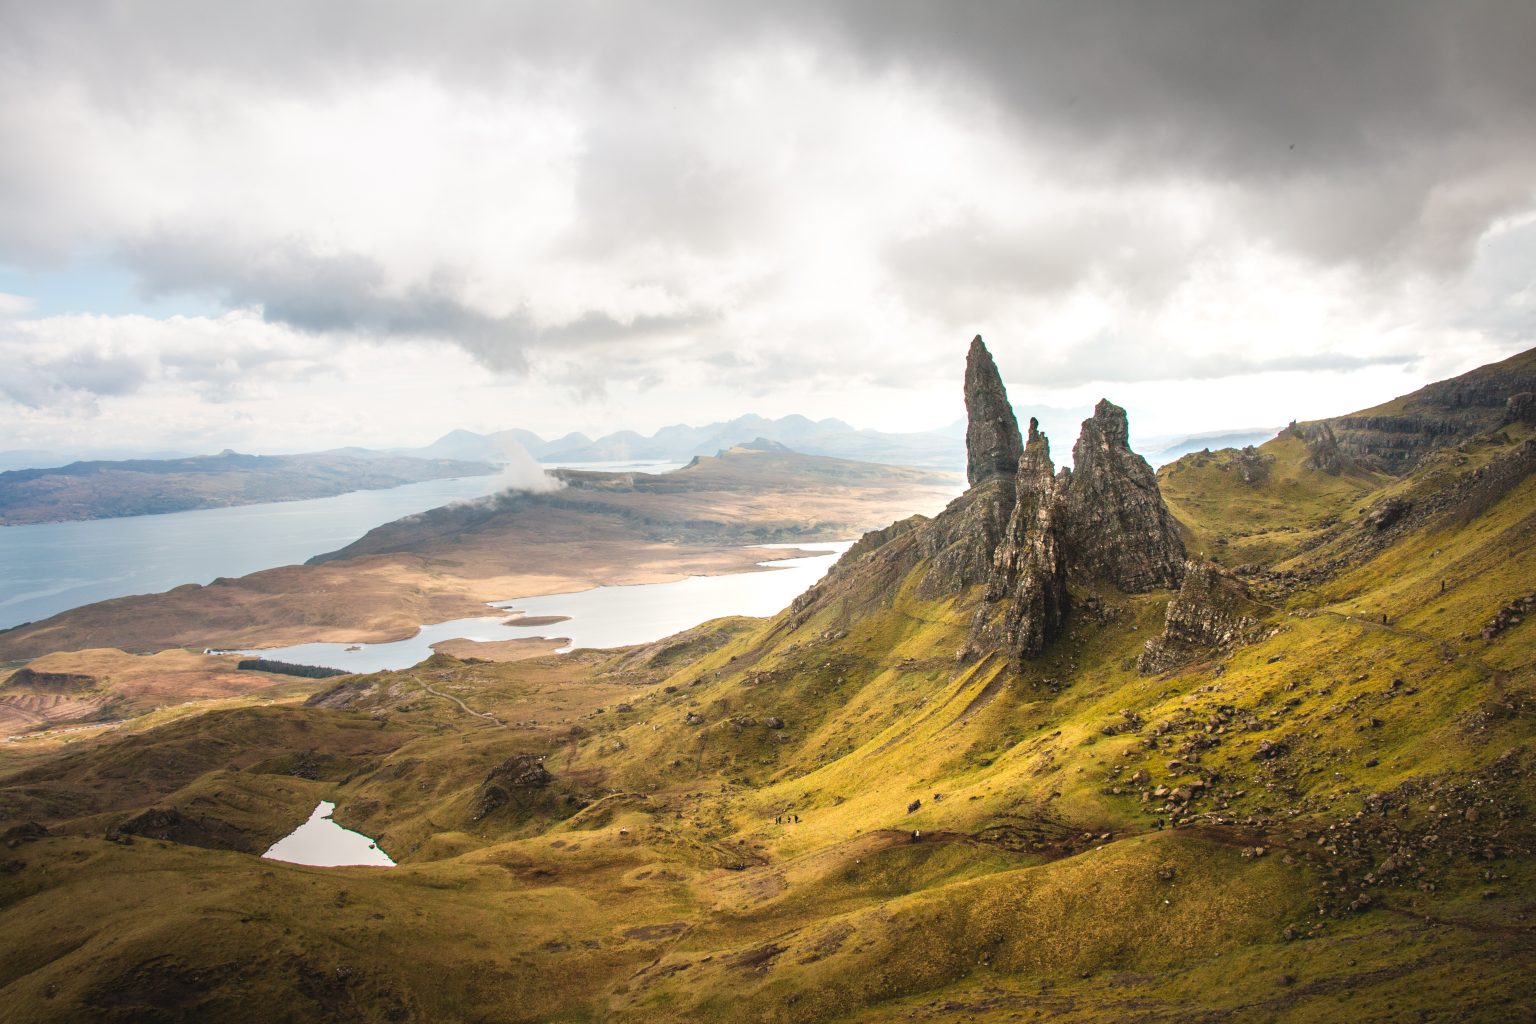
[0, 0, 1536, 451]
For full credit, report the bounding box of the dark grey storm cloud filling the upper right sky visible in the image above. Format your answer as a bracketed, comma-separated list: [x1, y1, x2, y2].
[842, 0, 1536, 288]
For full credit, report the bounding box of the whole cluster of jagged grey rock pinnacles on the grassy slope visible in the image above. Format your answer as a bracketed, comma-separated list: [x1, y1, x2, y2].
[791, 338, 1184, 669]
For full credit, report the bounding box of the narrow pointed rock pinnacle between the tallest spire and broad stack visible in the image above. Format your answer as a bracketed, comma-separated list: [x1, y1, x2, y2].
[971, 418, 1068, 659]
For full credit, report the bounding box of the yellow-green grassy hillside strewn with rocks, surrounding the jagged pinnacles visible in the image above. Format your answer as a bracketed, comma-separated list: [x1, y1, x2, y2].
[0, 379, 1536, 1022]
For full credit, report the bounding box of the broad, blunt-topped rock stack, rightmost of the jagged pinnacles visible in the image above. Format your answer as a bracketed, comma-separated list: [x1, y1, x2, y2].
[1057, 399, 1184, 594]
